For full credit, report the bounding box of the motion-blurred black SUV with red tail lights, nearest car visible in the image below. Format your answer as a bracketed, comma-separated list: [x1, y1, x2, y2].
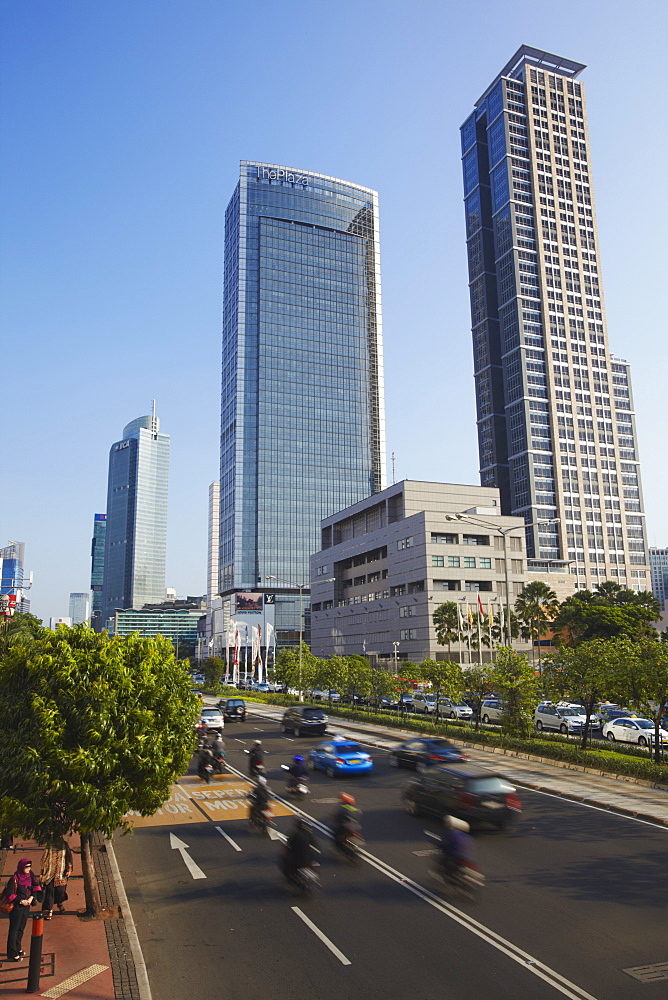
[403, 764, 522, 830]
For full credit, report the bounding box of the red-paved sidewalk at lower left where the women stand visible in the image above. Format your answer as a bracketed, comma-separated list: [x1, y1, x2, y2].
[0, 838, 146, 1000]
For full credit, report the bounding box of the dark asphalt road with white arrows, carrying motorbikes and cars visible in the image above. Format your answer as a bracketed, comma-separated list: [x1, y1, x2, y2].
[116, 716, 668, 1000]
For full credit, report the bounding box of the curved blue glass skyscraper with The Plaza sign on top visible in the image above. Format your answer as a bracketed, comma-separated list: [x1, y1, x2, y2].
[219, 161, 385, 642]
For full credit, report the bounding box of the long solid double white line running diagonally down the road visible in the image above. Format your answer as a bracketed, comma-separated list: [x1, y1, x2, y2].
[222, 756, 596, 1000]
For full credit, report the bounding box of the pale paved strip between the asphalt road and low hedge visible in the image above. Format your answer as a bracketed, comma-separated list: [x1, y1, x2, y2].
[247, 703, 668, 827]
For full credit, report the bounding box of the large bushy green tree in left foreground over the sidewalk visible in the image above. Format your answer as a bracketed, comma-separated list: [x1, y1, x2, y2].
[0, 625, 198, 915]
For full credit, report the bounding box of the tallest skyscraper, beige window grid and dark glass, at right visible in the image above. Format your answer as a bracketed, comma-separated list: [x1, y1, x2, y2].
[461, 45, 649, 590]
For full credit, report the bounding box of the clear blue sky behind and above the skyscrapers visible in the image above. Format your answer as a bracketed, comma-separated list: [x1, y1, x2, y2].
[0, 0, 668, 618]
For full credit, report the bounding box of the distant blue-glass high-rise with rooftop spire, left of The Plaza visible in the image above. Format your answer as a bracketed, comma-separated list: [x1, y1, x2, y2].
[102, 412, 169, 628]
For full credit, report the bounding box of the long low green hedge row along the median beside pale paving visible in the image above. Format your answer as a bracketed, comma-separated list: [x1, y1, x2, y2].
[231, 688, 668, 784]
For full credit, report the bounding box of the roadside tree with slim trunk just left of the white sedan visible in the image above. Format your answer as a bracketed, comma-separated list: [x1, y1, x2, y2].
[543, 639, 635, 750]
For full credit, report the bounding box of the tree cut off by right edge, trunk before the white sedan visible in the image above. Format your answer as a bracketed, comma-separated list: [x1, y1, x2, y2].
[614, 638, 668, 763]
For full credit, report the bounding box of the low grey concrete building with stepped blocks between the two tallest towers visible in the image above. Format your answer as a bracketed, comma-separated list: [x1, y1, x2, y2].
[310, 480, 527, 663]
